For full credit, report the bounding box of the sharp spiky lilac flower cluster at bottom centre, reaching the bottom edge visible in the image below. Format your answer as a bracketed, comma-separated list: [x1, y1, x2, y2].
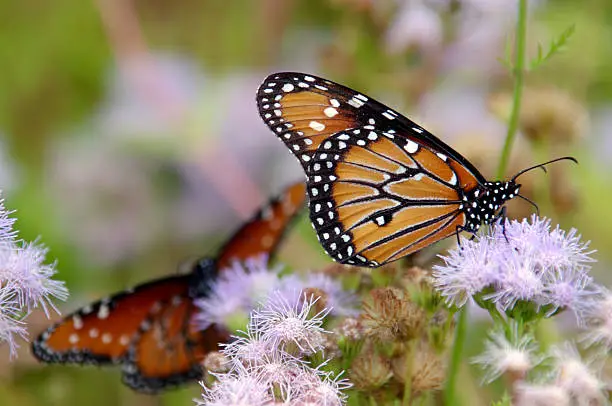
[197, 291, 351, 406]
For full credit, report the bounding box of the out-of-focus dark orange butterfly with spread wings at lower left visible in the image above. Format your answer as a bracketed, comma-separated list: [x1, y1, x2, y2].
[32, 183, 306, 393]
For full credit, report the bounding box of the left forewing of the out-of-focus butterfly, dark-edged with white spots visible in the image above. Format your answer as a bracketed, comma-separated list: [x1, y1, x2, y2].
[32, 275, 189, 364]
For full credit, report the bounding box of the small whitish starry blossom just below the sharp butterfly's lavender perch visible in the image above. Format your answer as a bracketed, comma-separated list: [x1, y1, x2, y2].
[472, 325, 542, 383]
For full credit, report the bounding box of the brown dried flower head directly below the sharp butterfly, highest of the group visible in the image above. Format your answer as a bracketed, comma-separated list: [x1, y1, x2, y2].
[361, 288, 425, 342]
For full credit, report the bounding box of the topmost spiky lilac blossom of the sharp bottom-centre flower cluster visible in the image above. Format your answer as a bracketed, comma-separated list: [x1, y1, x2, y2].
[251, 292, 330, 354]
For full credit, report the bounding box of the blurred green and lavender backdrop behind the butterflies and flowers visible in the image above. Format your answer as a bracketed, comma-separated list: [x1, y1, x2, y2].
[0, 0, 612, 406]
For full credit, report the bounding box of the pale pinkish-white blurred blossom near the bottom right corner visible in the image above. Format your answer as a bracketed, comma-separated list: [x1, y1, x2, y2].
[550, 343, 607, 405]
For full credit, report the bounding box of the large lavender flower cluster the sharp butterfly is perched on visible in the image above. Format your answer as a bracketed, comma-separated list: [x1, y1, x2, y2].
[433, 215, 598, 319]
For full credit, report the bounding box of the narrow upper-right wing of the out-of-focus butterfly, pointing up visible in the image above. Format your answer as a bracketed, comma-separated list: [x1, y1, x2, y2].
[217, 182, 306, 269]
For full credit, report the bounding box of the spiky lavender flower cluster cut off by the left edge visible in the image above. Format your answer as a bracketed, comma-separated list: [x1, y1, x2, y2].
[0, 200, 68, 356]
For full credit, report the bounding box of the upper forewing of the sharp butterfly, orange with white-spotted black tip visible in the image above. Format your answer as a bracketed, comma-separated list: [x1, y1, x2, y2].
[257, 72, 486, 186]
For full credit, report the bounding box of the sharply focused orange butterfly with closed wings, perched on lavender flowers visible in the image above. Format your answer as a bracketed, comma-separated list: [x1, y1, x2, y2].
[257, 72, 575, 267]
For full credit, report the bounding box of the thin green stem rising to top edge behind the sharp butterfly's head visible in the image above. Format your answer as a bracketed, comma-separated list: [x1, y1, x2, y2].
[497, 0, 527, 179]
